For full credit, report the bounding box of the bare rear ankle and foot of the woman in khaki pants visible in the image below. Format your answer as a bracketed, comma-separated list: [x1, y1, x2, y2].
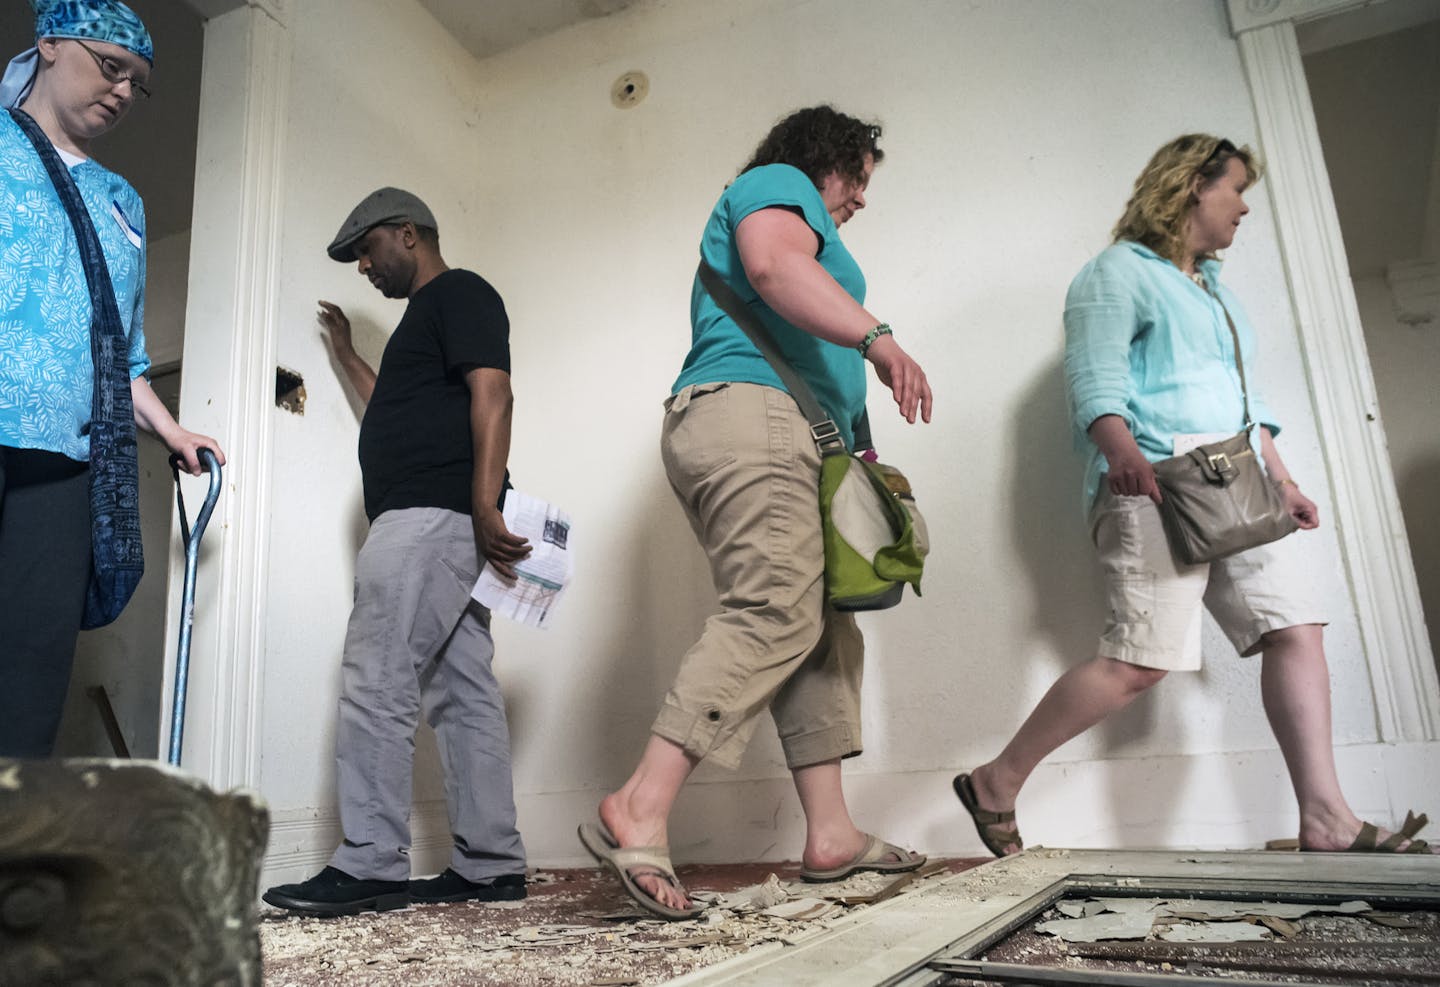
[600, 735, 698, 908]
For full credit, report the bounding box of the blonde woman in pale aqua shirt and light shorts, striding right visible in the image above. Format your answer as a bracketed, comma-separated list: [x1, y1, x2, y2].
[955, 134, 1430, 856]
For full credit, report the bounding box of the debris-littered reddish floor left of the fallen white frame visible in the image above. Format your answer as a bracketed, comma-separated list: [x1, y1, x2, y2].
[261, 860, 984, 987]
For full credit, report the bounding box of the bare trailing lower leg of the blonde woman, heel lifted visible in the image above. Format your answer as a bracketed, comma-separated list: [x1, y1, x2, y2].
[971, 657, 1165, 847]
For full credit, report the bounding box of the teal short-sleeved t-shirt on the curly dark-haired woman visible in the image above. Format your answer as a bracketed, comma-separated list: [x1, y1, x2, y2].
[671, 164, 865, 445]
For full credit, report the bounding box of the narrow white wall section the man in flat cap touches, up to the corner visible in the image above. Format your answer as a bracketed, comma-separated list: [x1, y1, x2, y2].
[254, 0, 489, 847]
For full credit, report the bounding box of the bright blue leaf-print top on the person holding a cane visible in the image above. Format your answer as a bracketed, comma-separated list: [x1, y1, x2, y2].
[0, 112, 150, 461]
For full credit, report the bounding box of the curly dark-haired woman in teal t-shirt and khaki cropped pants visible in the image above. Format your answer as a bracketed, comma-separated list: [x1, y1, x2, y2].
[580, 107, 930, 918]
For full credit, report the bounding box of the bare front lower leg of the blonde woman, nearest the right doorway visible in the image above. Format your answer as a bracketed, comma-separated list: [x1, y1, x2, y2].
[1260, 624, 1428, 850]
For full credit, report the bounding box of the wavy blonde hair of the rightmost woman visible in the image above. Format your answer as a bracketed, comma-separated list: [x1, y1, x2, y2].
[1115, 134, 1263, 267]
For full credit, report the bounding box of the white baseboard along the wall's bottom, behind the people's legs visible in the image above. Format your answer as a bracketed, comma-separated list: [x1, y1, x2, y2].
[262, 742, 1440, 888]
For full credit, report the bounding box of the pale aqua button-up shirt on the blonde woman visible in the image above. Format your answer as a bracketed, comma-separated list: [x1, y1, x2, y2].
[1066, 241, 1280, 509]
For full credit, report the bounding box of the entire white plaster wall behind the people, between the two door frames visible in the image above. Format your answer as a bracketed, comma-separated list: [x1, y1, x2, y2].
[239, 0, 1424, 877]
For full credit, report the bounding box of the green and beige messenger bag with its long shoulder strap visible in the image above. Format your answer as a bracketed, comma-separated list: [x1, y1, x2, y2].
[698, 261, 930, 611]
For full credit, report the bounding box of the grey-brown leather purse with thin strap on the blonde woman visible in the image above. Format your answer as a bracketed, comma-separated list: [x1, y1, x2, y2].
[1153, 285, 1299, 565]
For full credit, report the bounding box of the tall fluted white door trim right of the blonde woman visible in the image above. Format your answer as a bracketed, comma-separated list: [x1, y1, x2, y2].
[1231, 21, 1440, 742]
